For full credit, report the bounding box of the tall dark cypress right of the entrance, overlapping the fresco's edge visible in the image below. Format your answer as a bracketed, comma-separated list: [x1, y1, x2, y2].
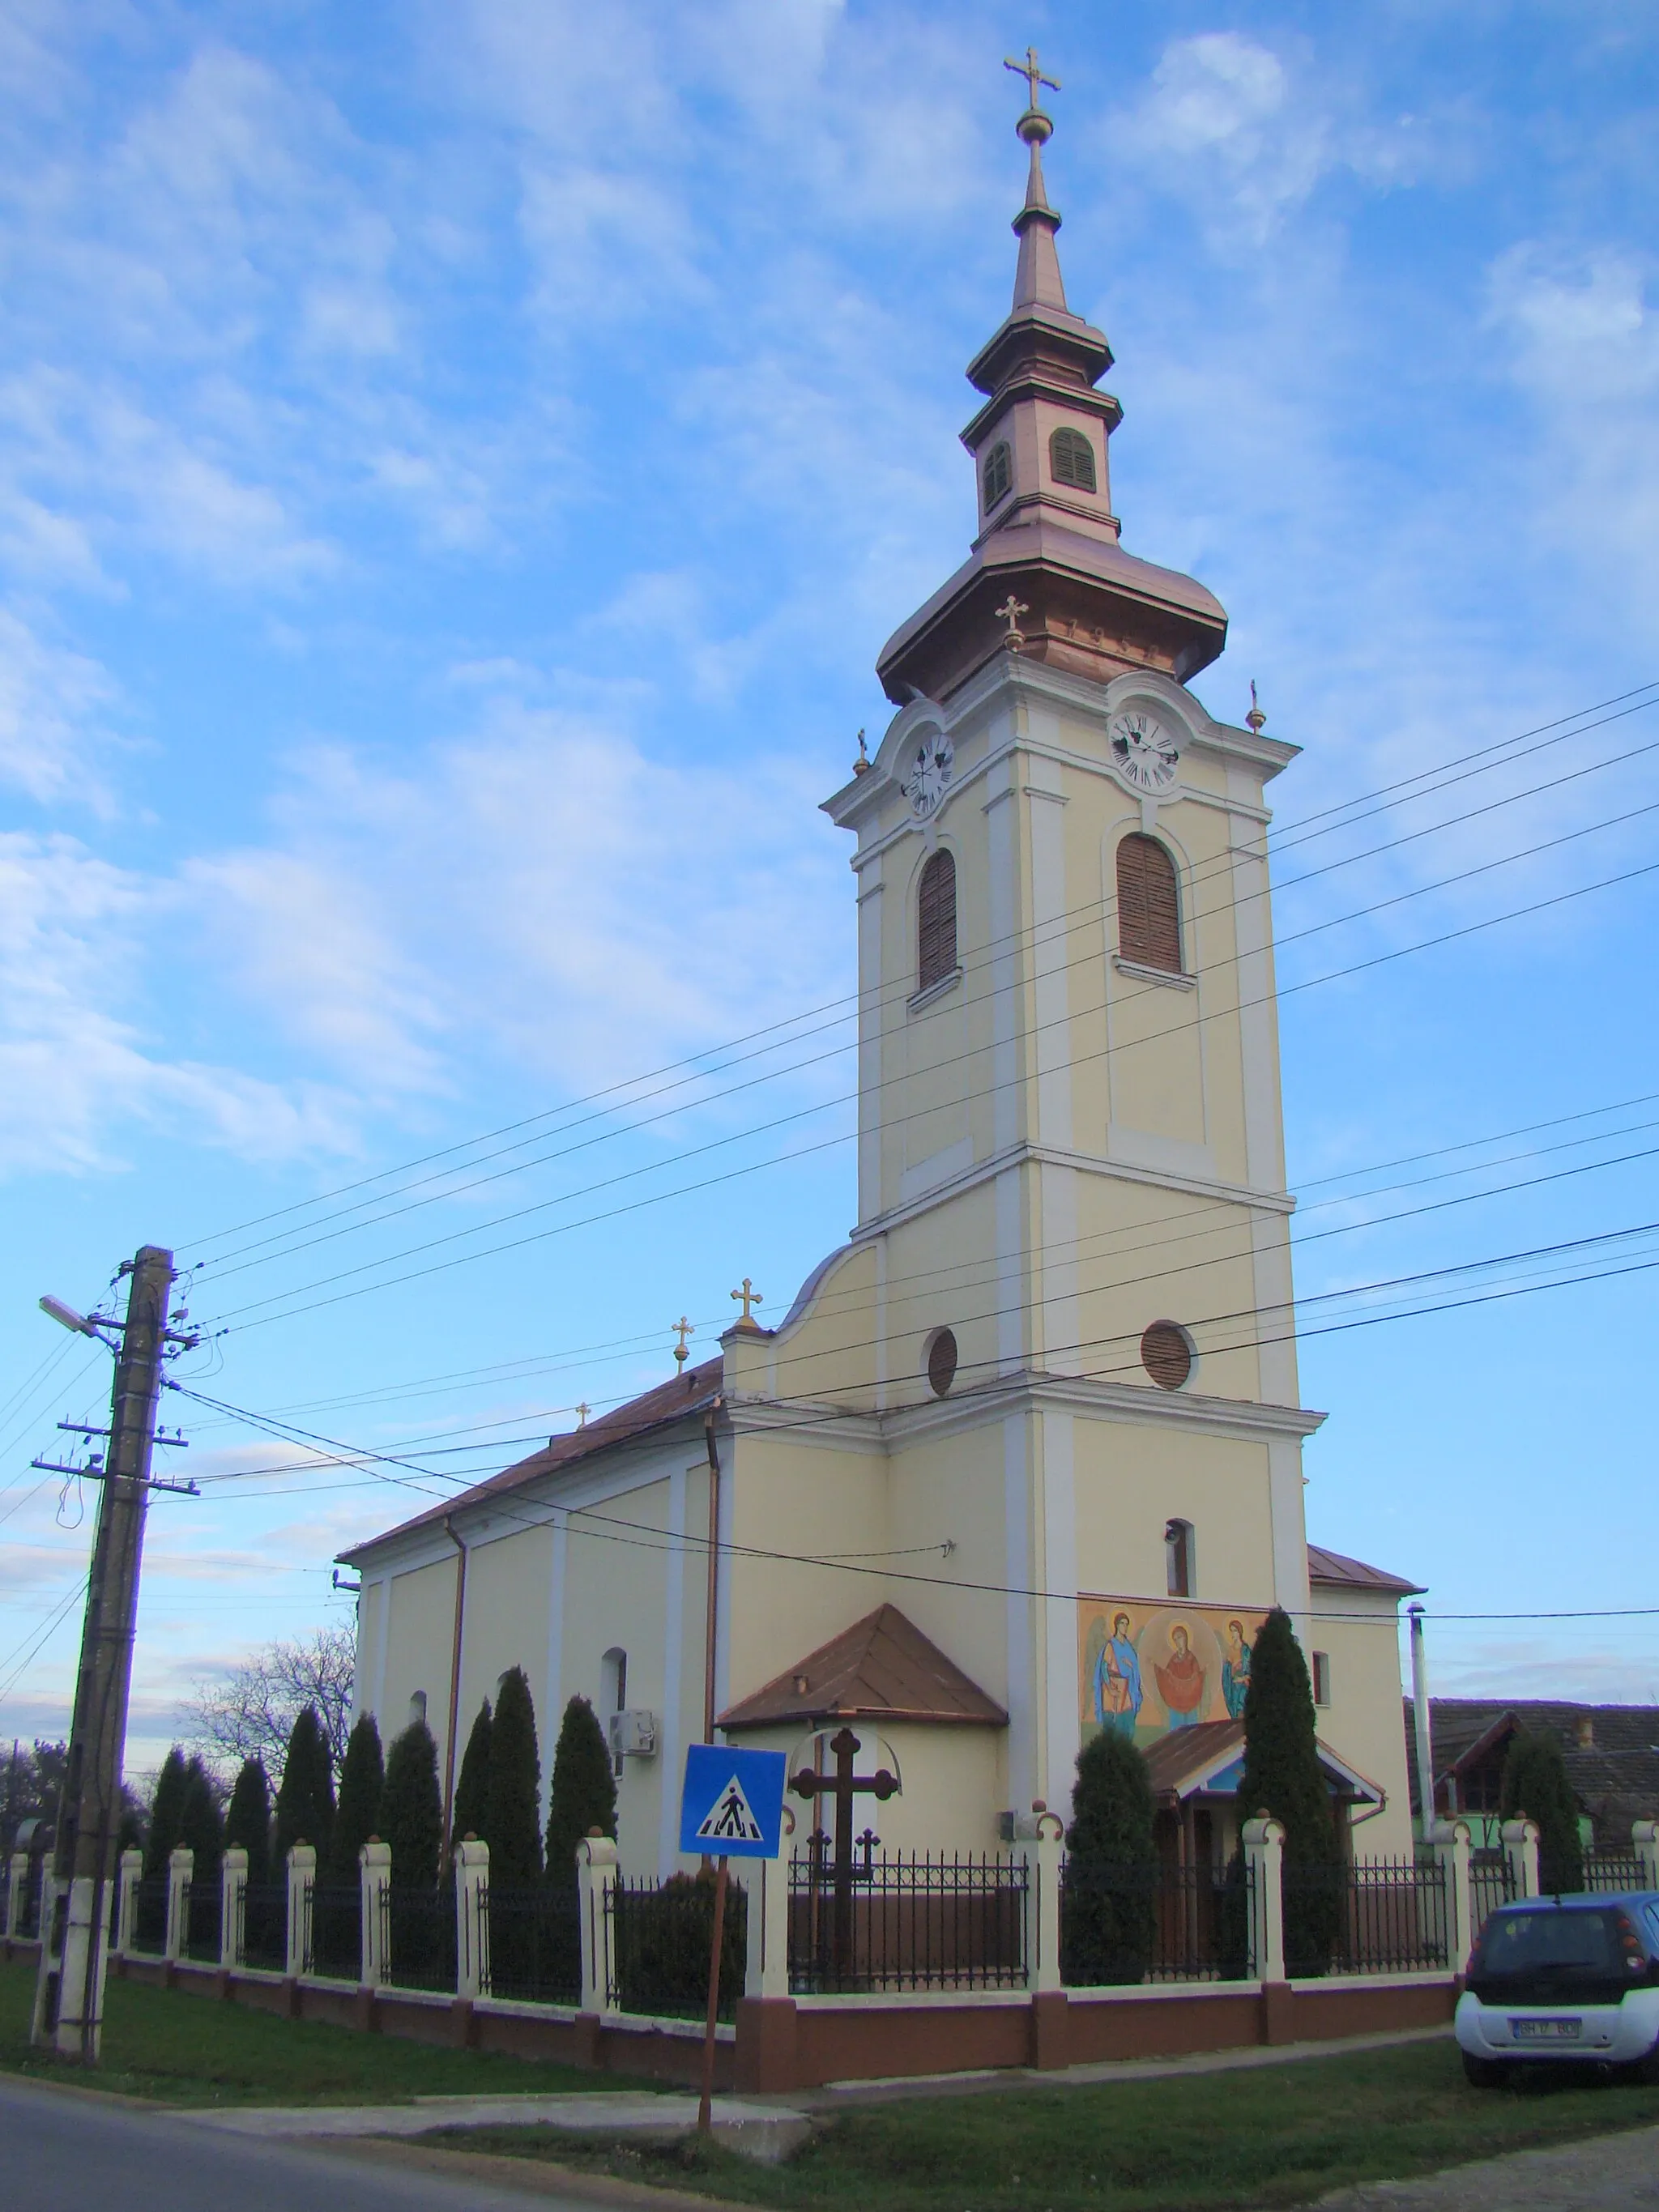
[1239, 1606, 1343, 1975]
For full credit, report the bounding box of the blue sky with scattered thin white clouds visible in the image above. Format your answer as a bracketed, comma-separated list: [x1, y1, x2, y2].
[0, 0, 1659, 1765]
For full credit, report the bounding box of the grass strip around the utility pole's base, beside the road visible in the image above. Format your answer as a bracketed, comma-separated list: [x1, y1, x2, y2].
[0, 1960, 661, 2106]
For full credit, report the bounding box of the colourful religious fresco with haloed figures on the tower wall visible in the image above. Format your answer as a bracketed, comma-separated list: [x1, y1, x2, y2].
[1077, 1597, 1268, 1750]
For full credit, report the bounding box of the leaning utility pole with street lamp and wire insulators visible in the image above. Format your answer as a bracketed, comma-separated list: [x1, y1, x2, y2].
[31, 1246, 190, 2066]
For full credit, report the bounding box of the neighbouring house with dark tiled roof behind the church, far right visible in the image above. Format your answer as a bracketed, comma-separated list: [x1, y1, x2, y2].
[1405, 1697, 1659, 1852]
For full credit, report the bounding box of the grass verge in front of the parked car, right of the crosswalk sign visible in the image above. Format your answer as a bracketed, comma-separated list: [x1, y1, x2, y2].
[433, 2039, 1659, 2212]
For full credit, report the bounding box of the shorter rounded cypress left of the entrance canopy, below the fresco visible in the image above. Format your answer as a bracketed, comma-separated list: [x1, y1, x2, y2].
[1064, 1728, 1157, 1984]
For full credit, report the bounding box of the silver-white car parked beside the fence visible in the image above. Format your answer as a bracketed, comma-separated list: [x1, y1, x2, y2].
[1456, 1889, 1659, 2088]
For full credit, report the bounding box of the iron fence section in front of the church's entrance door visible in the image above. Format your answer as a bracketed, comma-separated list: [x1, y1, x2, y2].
[1060, 1858, 1254, 1986]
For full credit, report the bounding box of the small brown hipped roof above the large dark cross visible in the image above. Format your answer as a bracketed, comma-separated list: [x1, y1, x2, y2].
[719, 1606, 1009, 1728]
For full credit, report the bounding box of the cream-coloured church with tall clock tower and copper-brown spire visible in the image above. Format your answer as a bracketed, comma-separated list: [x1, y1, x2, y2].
[343, 86, 1414, 1876]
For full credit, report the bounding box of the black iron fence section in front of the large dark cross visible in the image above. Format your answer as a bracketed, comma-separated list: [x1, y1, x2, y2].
[790, 1847, 1029, 1993]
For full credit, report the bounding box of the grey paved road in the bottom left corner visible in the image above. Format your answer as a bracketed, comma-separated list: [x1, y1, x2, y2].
[0, 2082, 593, 2212]
